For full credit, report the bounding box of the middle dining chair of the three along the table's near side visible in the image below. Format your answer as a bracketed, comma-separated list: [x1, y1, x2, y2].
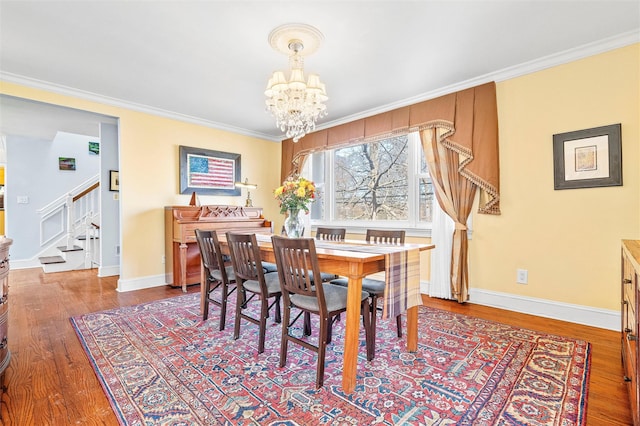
[226, 232, 282, 354]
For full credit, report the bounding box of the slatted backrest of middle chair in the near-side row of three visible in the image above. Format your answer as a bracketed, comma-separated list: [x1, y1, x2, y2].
[226, 232, 265, 284]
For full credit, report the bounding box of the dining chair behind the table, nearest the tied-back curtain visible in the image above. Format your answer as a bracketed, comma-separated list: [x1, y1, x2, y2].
[331, 229, 405, 348]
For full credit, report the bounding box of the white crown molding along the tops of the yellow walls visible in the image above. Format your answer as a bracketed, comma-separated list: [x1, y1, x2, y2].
[0, 29, 640, 142]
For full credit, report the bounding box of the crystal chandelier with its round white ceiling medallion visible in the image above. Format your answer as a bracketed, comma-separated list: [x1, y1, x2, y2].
[264, 24, 328, 142]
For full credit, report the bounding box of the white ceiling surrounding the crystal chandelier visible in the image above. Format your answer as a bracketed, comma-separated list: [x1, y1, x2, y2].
[0, 0, 640, 140]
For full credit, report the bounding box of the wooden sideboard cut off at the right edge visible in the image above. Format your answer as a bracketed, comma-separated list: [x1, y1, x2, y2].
[621, 240, 640, 425]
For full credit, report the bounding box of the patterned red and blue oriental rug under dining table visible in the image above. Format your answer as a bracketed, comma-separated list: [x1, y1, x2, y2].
[71, 294, 591, 425]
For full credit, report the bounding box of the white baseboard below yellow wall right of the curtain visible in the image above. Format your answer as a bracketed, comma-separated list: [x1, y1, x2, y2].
[469, 288, 620, 331]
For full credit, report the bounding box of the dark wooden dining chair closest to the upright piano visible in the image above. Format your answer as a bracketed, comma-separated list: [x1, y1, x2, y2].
[196, 229, 236, 331]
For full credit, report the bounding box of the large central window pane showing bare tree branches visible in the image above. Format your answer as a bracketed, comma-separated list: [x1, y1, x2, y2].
[334, 135, 409, 220]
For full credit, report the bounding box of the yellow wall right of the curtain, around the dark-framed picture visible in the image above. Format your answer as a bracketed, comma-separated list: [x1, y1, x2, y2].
[470, 44, 640, 310]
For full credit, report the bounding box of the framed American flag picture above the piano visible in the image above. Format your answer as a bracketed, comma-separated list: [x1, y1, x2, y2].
[180, 146, 240, 195]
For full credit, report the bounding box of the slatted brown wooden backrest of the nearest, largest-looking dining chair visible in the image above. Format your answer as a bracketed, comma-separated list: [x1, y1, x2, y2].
[271, 235, 327, 315]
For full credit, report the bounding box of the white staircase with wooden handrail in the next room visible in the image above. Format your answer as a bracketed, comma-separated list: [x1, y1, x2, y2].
[38, 177, 100, 273]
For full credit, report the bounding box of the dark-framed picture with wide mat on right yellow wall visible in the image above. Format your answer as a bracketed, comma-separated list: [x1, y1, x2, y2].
[553, 123, 622, 189]
